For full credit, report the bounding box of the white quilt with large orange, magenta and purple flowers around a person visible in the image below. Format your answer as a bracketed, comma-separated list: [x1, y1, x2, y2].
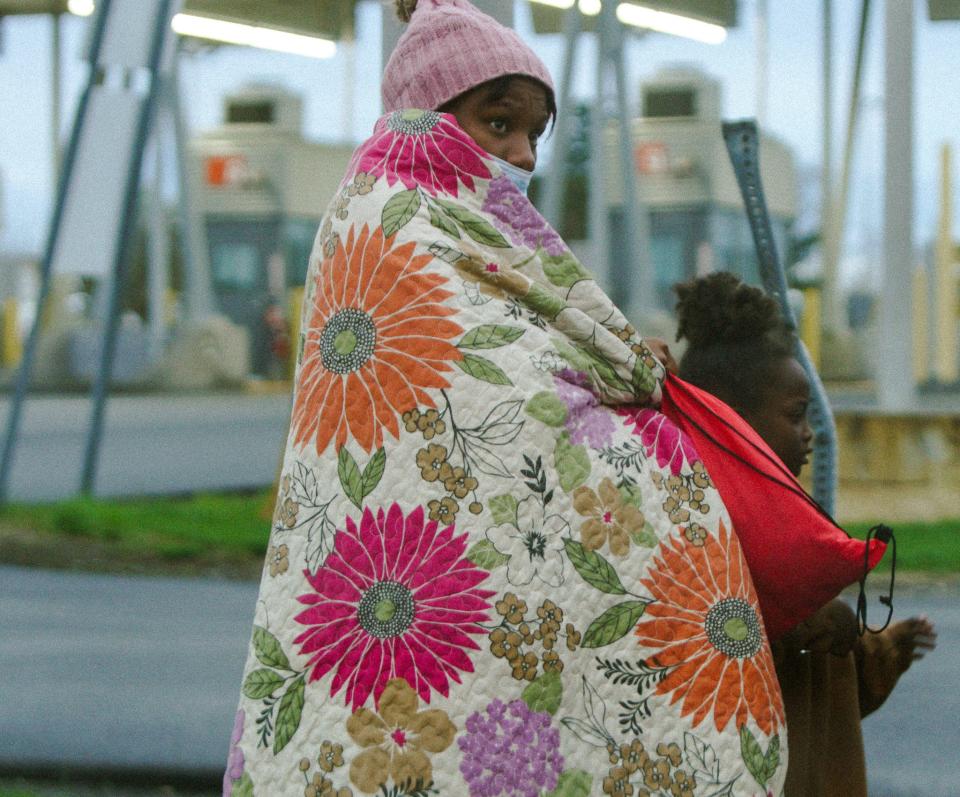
[224, 110, 786, 797]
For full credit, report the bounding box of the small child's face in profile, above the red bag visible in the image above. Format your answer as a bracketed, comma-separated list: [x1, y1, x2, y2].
[744, 357, 813, 476]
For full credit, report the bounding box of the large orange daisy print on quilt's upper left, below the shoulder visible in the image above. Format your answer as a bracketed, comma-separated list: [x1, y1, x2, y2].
[292, 225, 463, 454]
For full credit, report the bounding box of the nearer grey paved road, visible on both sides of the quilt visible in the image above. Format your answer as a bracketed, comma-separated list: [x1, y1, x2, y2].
[0, 567, 960, 797]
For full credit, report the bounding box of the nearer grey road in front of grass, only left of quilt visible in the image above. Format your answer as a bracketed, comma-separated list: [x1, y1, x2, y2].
[0, 567, 257, 772]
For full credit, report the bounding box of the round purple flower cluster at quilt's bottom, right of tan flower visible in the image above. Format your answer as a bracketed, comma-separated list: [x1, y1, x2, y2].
[457, 700, 563, 797]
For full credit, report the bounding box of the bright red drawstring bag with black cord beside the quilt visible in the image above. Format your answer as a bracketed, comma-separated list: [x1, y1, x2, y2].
[660, 375, 886, 639]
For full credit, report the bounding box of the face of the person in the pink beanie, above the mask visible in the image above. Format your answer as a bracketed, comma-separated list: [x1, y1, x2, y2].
[443, 77, 550, 172]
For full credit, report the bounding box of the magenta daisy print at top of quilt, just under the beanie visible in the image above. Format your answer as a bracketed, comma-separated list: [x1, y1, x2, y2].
[347, 109, 490, 196]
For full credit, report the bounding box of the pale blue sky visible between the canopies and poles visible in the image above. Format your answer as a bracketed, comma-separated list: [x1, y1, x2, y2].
[0, 0, 960, 281]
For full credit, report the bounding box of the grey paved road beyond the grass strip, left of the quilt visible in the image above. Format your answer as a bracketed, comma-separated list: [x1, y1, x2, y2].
[0, 393, 290, 501]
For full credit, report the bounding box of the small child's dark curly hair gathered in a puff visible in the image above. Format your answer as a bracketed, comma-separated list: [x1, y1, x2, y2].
[673, 271, 797, 412]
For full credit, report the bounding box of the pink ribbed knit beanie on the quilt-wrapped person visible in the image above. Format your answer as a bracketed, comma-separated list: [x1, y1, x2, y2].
[380, 0, 553, 112]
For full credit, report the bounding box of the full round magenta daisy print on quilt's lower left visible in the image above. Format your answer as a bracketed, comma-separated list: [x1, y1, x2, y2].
[294, 503, 494, 711]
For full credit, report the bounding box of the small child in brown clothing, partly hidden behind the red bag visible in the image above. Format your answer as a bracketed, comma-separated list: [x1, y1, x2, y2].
[675, 272, 936, 797]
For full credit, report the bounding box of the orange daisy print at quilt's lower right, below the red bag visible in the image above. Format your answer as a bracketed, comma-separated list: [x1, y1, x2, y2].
[634, 523, 783, 735]
